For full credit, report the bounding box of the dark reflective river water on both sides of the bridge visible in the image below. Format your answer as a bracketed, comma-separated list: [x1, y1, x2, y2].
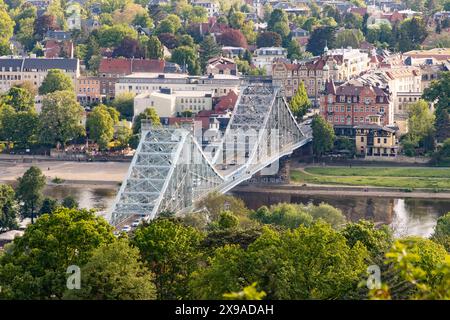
[45, 185, 450, 237]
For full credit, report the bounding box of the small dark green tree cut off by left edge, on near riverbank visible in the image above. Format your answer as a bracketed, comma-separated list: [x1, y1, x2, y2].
[0, 184, 19, 232]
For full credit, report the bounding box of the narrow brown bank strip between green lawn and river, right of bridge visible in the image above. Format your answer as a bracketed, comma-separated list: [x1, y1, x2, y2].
[233, 184, 450, 199]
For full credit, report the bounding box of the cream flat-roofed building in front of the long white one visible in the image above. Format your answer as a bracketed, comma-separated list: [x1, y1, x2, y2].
[134, 88, 213, 118]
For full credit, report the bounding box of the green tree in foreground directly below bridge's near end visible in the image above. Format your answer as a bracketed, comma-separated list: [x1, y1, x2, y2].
[133, 219, 203, 300]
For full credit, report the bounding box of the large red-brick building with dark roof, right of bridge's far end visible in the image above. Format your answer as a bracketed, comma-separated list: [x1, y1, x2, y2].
[320, 80, 394, 127]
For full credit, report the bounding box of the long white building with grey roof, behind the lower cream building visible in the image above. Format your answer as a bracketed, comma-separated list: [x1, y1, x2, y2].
[115, 73, 241, 97]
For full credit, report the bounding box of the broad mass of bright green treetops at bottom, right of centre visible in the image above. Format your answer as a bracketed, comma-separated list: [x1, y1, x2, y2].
[191, 223, 367, 299]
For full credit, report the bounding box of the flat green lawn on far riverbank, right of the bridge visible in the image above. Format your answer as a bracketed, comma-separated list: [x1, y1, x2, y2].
[291, 167, 450, 191]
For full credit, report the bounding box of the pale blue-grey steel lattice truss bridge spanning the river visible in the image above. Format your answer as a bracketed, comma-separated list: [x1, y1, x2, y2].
[111, 84, 312, 226]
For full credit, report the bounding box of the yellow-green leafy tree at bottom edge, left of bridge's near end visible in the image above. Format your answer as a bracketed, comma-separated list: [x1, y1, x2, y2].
[64, 239, 156, 300]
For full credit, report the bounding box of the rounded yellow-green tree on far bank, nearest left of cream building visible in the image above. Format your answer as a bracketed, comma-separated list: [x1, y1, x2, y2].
[86, 105, 114, 149]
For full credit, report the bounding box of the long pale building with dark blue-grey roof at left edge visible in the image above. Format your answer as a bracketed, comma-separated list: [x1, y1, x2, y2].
[0, 57, 80, 92]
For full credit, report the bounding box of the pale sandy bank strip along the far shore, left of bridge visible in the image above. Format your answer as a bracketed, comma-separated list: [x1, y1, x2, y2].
[0, 161, 130, 184]
